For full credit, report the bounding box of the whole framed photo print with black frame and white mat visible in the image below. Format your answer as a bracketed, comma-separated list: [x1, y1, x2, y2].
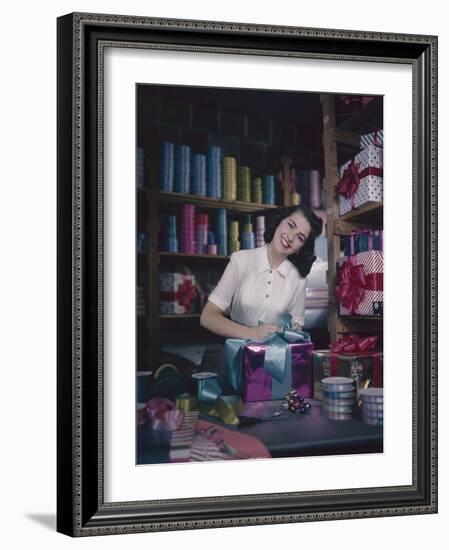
[58, 13, 437, 536]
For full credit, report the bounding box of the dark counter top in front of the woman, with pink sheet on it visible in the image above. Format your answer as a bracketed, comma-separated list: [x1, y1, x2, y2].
[137, 400, 383, 464]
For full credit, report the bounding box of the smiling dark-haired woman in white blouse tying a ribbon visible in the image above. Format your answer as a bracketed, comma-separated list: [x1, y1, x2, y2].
[200, 206, 322, 339]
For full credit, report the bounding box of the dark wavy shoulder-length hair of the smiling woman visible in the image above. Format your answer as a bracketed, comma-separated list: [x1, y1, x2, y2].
[263, 204, 323, 277]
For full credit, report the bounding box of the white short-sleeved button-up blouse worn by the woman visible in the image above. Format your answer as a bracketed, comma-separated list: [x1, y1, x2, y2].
[209, 244, 307, 327]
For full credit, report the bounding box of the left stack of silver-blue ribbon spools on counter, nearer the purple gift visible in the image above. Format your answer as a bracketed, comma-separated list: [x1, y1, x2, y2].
[321, 376, 355, 420]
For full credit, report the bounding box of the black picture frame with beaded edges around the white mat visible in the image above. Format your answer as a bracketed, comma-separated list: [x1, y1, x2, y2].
[57, 13, 437, 536]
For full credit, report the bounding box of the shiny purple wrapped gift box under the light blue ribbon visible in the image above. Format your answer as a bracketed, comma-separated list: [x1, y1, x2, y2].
[242, 342, 313, 402]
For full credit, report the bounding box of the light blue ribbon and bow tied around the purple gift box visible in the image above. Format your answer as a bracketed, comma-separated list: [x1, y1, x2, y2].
[225, 314, 310, 393]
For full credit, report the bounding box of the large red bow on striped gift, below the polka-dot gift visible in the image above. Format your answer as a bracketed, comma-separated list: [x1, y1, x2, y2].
[335, 256, 383, 314]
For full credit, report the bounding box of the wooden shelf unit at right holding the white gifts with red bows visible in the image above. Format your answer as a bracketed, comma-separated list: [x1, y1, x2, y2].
[321, 94, 383, 342]
